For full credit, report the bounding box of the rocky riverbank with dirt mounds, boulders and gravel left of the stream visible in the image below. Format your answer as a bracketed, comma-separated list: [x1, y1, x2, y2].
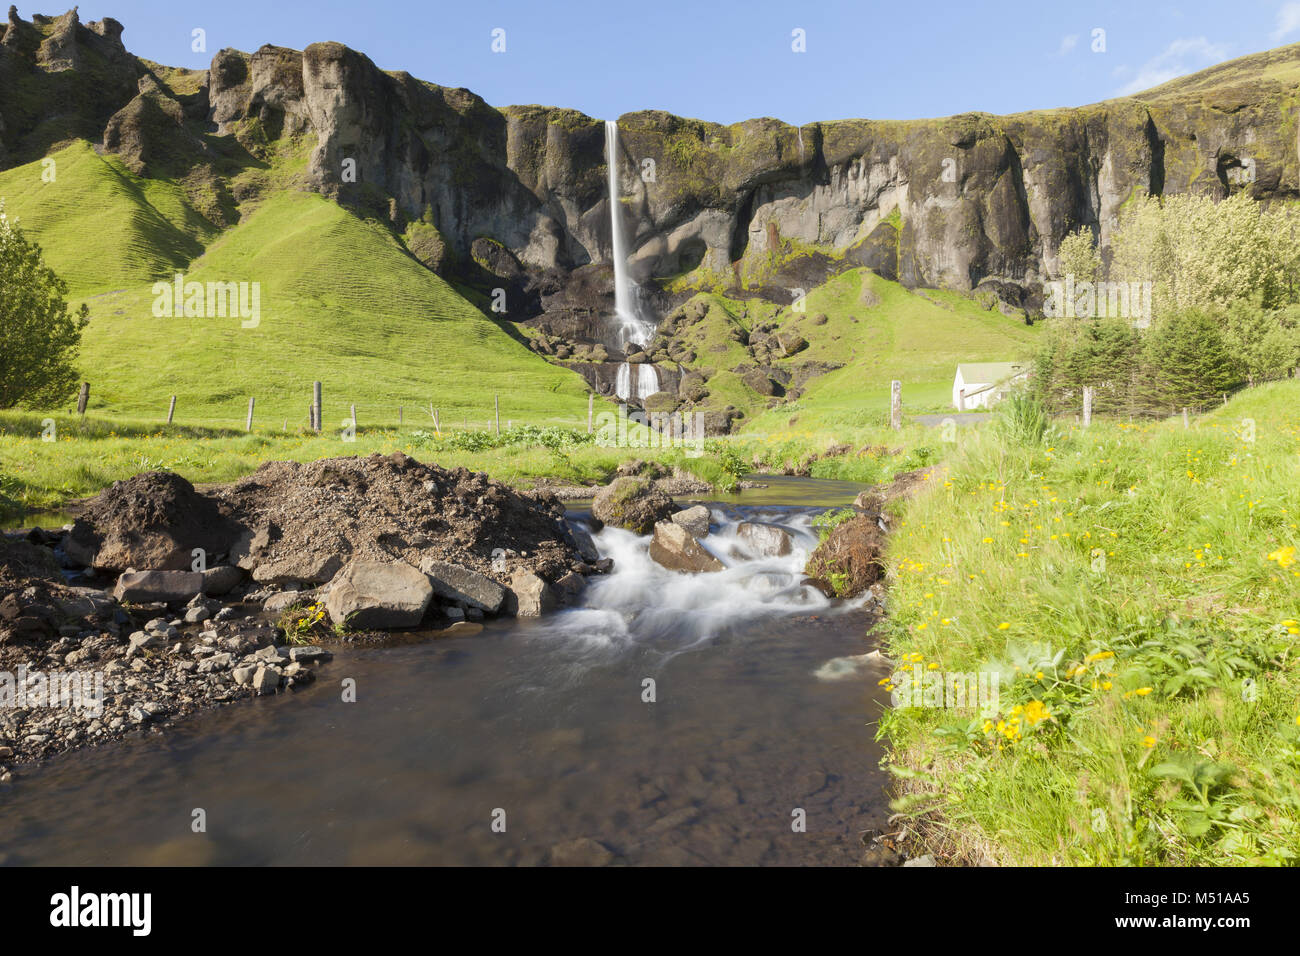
[0, 454, 608, 780]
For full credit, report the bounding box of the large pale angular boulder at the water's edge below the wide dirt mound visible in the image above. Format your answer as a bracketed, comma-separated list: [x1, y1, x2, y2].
[325, 558, 433, 631]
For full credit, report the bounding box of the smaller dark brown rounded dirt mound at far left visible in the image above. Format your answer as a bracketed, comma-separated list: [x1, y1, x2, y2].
[64, 471, 238, 571]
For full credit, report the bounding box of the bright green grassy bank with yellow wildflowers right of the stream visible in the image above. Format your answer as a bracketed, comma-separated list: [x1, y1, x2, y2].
[881, 381, 1300, 865]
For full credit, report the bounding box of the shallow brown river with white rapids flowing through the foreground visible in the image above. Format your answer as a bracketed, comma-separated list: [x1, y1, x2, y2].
[0, 479, 889, 865]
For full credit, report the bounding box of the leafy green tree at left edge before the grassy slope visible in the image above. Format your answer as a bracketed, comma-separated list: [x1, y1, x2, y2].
[0, 200, 90, 408]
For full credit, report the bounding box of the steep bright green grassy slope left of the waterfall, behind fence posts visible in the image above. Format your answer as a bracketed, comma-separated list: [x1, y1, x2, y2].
[0, 146, 586, 424]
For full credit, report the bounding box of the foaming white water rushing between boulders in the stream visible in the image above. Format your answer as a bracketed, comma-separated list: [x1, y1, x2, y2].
[534, 507, 858, 653]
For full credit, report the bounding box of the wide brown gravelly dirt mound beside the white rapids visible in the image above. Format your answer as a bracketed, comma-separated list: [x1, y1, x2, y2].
[215, 451, 582, 584]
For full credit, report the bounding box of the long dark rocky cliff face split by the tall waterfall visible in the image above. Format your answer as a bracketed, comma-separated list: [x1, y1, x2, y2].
[0, 8, 1300, 317]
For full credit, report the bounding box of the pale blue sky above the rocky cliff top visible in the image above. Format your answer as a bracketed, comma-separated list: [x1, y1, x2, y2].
[73, 0, 1300, 124]
